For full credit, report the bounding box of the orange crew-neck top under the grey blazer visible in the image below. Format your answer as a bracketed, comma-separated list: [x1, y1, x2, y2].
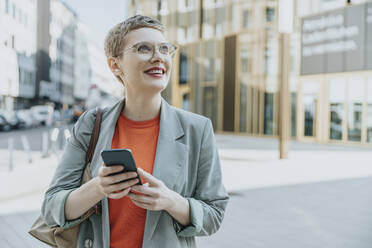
[109, 114, 160, 248]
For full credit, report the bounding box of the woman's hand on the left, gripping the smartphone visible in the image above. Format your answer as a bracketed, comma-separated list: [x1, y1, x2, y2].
[96, 163, 138, 199]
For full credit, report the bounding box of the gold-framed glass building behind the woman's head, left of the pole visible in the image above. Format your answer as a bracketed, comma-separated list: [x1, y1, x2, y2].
[129, 0, 278, 138]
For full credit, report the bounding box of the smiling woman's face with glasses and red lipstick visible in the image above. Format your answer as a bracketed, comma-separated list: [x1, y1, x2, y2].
[113, 28, 172, 95]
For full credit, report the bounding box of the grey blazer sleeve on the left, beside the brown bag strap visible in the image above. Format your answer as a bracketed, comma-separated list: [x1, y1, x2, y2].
[41, 110, 95, 228]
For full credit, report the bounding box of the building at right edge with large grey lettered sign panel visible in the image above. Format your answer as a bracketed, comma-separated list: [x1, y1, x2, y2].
[297, 0, 372, 145]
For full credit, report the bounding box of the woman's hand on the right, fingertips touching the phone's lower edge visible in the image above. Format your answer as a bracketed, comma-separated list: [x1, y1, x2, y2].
[128, 168, 175, 211]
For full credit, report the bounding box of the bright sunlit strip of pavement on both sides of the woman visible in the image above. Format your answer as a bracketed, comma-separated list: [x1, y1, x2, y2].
[0, 136, 372, 214]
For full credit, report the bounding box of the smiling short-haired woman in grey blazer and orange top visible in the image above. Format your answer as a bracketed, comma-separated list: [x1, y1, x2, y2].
[42, 15, 228, 248]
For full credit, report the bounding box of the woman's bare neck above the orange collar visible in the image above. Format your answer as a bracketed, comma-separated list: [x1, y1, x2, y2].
[122, 94, 161, 121]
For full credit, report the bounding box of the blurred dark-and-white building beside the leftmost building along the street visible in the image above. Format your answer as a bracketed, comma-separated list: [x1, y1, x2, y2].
[35, 0, 78, 105]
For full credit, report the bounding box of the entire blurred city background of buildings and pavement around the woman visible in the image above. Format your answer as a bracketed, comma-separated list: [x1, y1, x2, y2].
[0, 0, 372, 248]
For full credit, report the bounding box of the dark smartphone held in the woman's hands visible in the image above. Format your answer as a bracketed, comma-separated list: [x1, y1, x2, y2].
[101, 149, 142, 185]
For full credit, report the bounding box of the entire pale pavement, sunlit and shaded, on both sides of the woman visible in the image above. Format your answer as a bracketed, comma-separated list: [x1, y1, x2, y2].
[0, 135, 372, 248]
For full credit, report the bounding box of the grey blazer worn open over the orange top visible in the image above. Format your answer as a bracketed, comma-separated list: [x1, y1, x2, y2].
[42, 99, 229, 248]
